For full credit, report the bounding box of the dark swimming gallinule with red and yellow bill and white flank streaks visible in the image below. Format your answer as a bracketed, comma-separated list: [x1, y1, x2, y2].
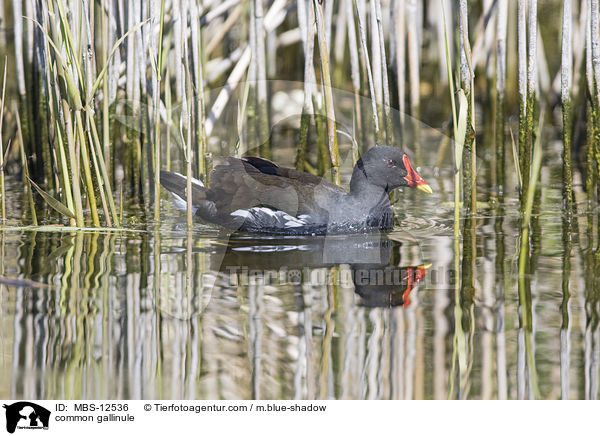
[160, 145, 432, 235]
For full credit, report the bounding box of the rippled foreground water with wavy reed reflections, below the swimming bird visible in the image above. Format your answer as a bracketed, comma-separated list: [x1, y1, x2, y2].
[0, 218, 600, 399]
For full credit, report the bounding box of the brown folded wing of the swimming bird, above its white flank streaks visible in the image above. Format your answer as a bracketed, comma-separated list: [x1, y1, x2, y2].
[209, 158, 345, 216]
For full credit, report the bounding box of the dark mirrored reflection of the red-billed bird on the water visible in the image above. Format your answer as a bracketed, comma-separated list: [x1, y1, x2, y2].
[211, 233, 429, 307]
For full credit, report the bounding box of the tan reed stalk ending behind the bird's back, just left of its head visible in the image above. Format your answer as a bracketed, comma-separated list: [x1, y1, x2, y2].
[313, 0, 340, 185]
